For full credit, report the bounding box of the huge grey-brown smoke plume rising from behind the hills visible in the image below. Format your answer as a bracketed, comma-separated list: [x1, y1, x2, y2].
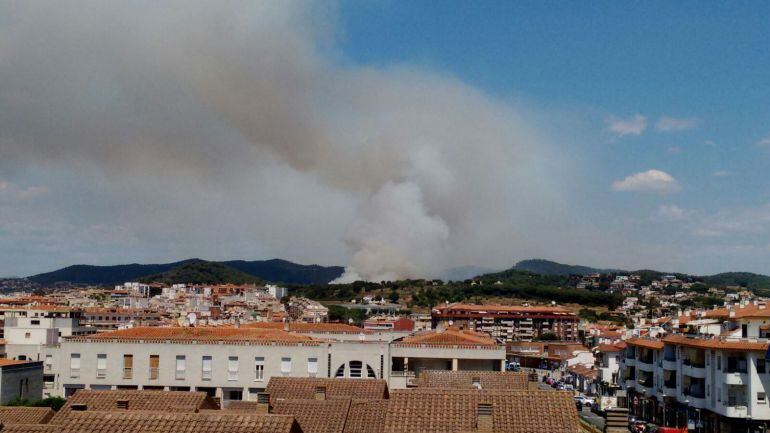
[0, 1, 566, 281]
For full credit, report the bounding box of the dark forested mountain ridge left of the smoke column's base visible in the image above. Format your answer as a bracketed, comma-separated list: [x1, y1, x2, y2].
[28, 259, 345, 286]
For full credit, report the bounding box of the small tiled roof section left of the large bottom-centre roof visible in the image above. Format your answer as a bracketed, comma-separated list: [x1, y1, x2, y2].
[272, 400, 350, 433]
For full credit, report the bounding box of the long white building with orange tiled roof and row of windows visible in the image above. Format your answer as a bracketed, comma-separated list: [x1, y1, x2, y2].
[44, 323, 505, 401]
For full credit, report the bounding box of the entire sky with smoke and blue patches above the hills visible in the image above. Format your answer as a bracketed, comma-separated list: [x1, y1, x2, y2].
[0, 1, 770, 279]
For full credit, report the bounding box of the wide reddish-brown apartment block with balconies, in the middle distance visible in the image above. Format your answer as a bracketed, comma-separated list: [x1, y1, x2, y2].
[431, 303, 580, 341]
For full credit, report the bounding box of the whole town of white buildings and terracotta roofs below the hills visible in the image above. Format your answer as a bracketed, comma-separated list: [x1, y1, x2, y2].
[0, 264, 770, 432]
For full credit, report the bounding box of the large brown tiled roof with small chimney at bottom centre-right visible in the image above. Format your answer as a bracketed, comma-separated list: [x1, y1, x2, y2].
[384, 388, 580, 433]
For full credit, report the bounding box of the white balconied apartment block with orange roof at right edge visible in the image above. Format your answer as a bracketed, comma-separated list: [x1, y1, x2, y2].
[621, 304, 770, 432]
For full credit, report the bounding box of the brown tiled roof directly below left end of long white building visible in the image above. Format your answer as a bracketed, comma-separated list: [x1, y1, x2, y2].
[51, 389, 218, 424]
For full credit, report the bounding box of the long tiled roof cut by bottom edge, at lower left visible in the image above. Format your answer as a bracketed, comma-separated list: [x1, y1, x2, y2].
[42, 411, 302, 433]
